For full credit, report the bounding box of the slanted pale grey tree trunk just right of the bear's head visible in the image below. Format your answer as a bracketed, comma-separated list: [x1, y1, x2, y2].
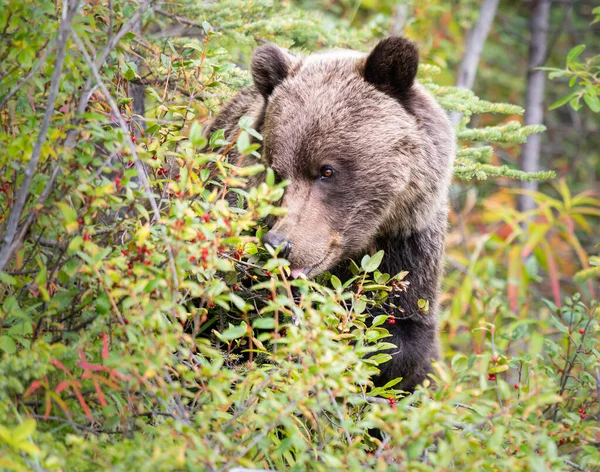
[450, 0, 499, 126]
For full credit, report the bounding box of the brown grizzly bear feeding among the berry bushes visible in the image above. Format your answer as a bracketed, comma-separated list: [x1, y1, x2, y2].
[207, 37, 455, 391]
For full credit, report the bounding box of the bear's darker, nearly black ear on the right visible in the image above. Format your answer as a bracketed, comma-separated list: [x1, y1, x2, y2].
[363, 36, 419, 95]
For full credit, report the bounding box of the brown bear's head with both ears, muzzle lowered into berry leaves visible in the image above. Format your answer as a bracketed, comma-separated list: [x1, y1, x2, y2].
[252, 37, 454, 277]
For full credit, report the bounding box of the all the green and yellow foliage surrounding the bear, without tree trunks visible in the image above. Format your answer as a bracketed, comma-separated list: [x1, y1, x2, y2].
[0, 0, 600, 471]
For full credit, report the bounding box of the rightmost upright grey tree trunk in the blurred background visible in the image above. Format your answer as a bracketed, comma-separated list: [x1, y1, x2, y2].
[519, 0, 552, 211]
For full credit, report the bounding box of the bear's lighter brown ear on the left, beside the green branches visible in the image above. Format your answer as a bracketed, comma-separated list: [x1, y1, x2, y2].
[252, 44, 292, 98]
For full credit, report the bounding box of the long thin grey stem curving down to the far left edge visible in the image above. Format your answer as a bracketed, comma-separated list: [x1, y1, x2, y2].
[0, 0, 79, 272]
